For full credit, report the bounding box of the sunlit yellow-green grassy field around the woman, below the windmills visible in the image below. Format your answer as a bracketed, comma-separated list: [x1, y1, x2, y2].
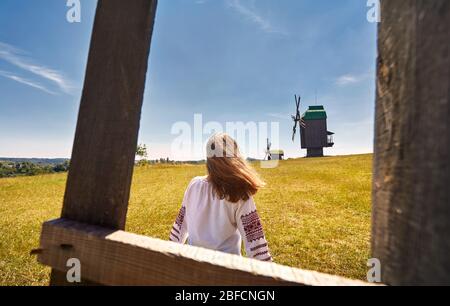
[0, 155, 372, 285]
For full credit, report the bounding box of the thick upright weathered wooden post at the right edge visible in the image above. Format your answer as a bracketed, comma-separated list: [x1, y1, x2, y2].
[372, 0, 450, 285]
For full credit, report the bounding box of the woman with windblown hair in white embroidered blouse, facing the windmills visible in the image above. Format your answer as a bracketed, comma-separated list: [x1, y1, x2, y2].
[170, 133, 272, 261]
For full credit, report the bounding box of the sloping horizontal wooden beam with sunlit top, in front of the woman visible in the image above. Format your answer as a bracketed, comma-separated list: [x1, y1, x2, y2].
[38, 219, 367, 286]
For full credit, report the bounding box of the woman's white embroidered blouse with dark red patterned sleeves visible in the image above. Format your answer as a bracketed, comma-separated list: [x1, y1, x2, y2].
[170, 177, 272, 261]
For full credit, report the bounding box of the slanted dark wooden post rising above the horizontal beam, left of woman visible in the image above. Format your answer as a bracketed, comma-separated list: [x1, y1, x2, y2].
[51, 0, 157, 285]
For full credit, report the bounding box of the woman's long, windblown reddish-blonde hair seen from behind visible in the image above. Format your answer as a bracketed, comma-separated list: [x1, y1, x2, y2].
[206, 133, 264, 203]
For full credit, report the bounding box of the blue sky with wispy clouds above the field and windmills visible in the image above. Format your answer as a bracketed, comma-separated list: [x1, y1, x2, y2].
[0, 0, 376, 159]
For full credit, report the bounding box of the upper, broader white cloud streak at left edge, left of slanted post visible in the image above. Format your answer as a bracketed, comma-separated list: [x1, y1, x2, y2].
[0, 42, 73, 93]
